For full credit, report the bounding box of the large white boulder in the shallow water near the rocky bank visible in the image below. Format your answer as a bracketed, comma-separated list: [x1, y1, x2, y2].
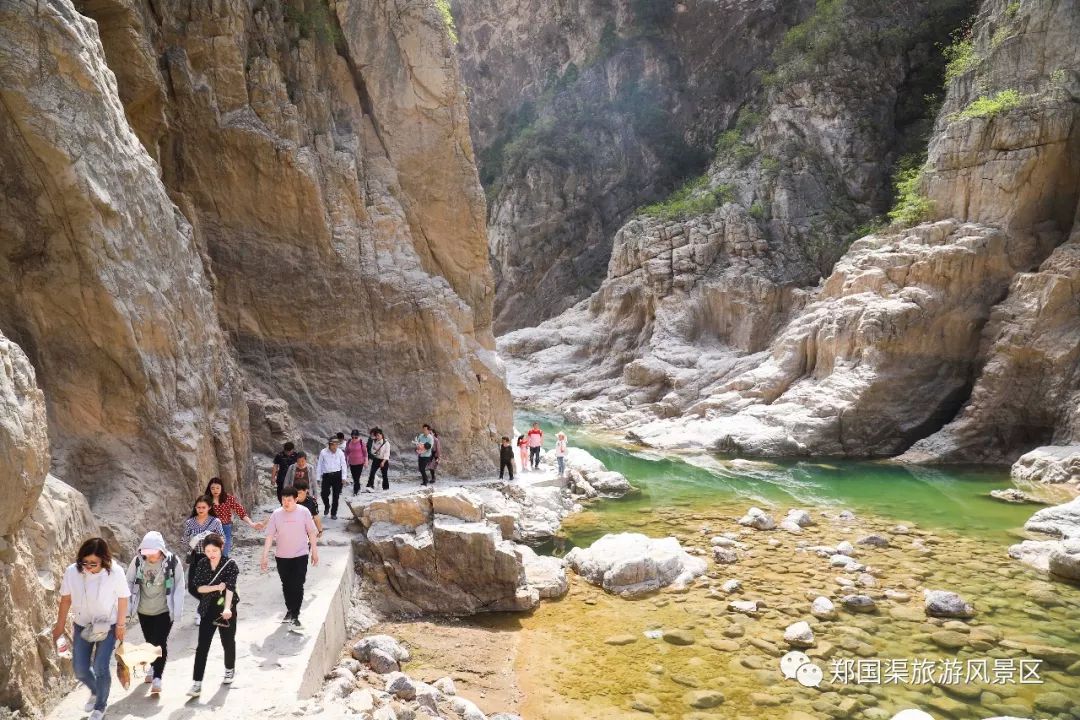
[565, 532, 707, 597]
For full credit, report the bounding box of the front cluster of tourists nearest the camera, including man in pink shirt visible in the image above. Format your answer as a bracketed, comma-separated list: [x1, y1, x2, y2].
[53, 472, 322, 720]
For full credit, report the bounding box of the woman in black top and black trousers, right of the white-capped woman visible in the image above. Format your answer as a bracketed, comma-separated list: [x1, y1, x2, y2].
[188, 533, 240, 697]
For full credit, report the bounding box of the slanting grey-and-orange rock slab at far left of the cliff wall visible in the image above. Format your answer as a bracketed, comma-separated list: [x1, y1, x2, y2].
[0, 2, 251, 542]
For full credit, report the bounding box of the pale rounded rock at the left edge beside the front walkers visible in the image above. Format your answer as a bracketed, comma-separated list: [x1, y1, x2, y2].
[0, 336, 96, 717]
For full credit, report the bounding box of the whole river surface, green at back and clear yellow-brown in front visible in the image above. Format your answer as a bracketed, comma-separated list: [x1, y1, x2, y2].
[501, 416, 1080, 720]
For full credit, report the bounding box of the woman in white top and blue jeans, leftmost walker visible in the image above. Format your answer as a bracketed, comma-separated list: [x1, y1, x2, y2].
[53, 538, 131, 720]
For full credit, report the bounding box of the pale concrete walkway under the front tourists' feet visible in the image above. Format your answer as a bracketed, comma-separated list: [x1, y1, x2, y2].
[48, 514, 354, 720]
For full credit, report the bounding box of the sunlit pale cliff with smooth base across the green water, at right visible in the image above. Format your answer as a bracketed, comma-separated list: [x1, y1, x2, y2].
[500, 2, 1080, 460]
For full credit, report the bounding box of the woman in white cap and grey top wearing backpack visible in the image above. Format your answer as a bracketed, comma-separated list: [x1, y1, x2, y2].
[127, 530, 187, 695]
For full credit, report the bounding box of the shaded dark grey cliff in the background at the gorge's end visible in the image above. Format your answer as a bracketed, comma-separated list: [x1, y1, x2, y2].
[454, 0, 972, 332]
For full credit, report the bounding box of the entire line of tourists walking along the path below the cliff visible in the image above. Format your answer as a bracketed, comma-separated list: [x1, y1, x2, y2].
[53, 423, 567, 720]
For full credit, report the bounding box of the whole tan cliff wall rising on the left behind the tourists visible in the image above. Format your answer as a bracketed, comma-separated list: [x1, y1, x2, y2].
[0, 0, 510, 561]
